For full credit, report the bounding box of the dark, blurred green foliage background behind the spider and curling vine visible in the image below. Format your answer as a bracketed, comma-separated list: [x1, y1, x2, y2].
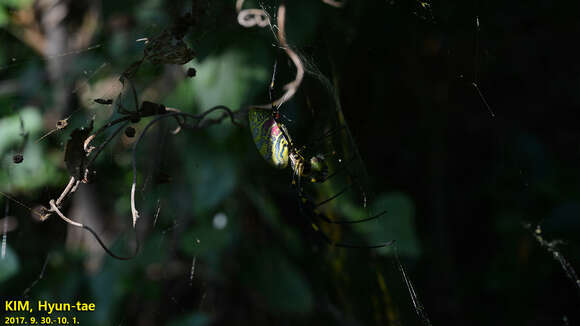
[0, 0, 580, 325]
